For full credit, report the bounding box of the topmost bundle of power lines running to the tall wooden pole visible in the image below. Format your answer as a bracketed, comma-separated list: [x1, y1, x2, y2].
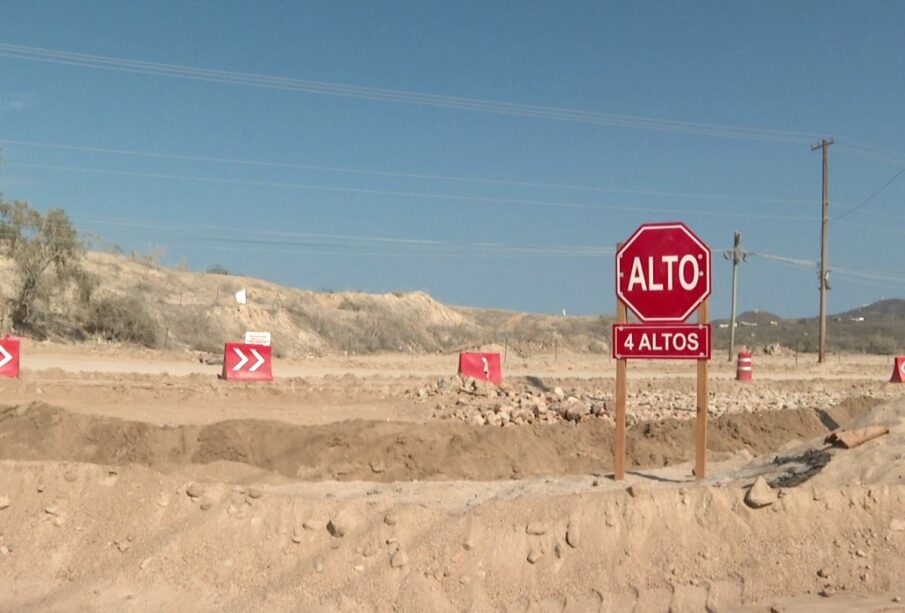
[0, 43, 814, 144]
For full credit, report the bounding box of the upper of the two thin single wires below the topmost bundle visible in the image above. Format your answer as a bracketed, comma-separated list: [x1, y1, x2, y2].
[0, 138, 810, 204]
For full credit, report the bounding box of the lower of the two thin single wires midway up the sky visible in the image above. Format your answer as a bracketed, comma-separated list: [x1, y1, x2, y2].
[1, 162, 813, 221]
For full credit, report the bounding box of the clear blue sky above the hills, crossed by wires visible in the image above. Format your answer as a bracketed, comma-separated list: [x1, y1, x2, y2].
[0, 0, 905, 317]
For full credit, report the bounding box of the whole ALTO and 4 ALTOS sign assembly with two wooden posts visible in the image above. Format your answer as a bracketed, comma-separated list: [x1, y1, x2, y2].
[613, 222, 711, 481]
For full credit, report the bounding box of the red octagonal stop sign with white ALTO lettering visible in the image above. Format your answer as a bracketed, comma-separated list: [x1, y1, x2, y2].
[616, 222, 710, 322]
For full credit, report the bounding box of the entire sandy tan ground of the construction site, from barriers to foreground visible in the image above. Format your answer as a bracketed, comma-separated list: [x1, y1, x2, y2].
[0, 343, 905, 612]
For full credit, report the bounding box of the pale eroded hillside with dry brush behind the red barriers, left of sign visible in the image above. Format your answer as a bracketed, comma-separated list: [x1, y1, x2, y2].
[0, 252, 609, 356]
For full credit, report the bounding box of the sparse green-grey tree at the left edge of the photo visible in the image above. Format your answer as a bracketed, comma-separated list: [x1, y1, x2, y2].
[0, 200, 82, 330]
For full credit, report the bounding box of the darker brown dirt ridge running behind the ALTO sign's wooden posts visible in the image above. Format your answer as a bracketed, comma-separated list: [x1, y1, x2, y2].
[0, 398, 878, 481]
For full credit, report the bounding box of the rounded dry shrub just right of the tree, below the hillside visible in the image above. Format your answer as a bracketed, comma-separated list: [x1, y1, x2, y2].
[83, 296, 158, 347]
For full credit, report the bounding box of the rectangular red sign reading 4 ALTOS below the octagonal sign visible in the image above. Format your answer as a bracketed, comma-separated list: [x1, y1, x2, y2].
[613, 324, 710, 360]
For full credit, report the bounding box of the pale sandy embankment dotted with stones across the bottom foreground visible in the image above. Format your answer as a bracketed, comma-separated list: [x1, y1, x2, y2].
[0, 462, 905, 613]
